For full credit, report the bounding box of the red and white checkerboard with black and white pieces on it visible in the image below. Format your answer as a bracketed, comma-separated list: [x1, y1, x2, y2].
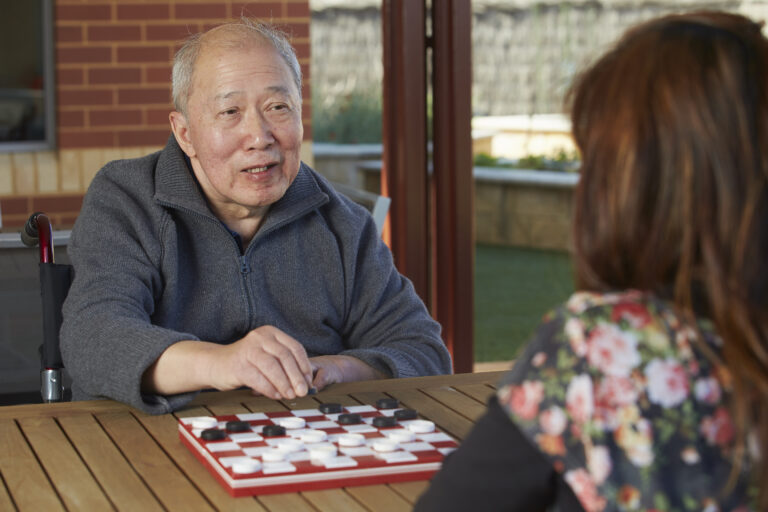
[179, 398, 457, 496]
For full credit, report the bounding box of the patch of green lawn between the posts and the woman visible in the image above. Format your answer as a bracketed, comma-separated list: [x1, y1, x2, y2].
[475, 245, 573, 362]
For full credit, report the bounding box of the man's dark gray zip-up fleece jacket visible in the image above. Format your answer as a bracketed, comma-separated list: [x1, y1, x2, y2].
[61, 137, 451, 413]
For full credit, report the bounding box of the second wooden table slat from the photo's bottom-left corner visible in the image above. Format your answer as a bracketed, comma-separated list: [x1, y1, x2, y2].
[0, 420, 64, 512]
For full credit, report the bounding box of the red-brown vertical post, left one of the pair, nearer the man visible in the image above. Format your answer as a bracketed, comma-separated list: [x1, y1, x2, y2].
[382, 0, 430, 305]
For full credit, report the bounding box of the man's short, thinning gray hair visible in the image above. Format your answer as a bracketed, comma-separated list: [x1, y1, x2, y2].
[172, 17, 301, 116]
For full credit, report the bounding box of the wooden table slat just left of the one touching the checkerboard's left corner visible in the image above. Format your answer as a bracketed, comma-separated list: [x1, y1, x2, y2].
[96, 412, 212, 510]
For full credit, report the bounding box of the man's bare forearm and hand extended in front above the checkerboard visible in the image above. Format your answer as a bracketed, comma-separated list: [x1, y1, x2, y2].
[142, 325, 312, 399]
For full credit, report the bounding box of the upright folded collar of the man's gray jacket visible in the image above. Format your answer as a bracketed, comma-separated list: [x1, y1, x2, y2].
[154, 135, 329, 236]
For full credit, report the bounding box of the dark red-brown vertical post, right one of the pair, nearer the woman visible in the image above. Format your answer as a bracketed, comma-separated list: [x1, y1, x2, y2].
[432, 0, 475, 373]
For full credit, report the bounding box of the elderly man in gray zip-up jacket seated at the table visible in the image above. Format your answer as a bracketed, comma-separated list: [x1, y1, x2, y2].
[62, 20, 451, 413]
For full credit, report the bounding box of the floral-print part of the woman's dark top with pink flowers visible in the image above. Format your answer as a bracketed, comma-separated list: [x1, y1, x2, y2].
[497, 291, 751, 512]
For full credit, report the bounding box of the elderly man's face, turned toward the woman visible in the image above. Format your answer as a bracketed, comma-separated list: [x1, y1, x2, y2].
[171, 36, 303, 222]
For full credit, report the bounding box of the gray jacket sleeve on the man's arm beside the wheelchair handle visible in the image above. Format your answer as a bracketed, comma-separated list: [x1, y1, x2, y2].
[61, 162, 197, 413]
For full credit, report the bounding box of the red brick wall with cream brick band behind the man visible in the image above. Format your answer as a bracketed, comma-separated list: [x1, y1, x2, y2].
[0, 0, 312, 231]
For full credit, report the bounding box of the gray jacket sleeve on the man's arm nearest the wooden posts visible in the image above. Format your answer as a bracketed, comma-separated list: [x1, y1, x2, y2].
[334, 206, 452, 377]
